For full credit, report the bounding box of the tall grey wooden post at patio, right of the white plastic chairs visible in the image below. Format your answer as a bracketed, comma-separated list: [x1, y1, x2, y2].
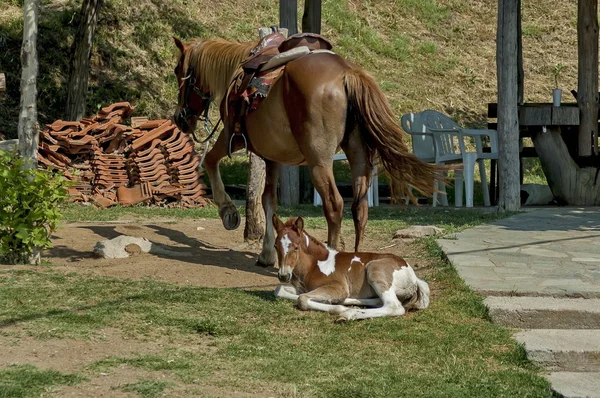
[496, 0, 520, 211]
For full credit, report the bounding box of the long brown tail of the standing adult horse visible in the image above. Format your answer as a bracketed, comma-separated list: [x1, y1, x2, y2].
[344, 67, 445, 202]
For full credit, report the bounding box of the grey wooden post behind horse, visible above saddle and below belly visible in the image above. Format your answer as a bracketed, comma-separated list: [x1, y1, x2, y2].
[279, 0, 300, 206]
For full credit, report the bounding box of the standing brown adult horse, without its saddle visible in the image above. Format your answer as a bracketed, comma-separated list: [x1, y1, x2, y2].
[174, 38, 440, 266]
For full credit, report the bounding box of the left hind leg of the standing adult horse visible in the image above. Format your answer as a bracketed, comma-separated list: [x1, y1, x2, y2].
[308, 164, 344, 250]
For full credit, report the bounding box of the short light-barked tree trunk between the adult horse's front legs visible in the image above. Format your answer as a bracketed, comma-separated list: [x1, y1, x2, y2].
[244, 153, 266, 243]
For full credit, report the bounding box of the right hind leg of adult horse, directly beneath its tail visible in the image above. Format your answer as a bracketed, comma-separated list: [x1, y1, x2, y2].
[343, 129, 373, 251]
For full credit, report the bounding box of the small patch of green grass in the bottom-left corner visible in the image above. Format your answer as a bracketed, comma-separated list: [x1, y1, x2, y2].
[0, 365, 85, 398]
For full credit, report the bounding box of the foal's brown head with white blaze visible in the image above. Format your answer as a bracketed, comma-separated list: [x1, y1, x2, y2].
[273, 214, 306, 283]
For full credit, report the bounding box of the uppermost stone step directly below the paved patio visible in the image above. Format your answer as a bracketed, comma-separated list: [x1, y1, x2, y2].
[484, 296, 600, 329]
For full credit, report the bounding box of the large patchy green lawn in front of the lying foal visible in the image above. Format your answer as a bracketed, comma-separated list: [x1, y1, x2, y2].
[0, 249, 550, 397]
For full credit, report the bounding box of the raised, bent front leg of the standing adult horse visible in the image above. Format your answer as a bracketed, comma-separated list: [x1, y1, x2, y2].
[204, 134, 241, 230]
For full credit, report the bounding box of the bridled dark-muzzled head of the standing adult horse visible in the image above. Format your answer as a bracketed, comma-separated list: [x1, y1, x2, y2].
[173, 37, 211, 134]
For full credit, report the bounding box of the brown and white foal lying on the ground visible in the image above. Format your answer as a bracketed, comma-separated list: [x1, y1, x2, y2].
[273, 214, 429, 321]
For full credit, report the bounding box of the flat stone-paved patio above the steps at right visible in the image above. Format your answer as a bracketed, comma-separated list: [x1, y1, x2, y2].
[438, 207, 600, 298]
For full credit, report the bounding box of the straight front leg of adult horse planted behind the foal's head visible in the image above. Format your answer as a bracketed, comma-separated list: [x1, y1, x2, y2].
[256, 160, 281, 267]
